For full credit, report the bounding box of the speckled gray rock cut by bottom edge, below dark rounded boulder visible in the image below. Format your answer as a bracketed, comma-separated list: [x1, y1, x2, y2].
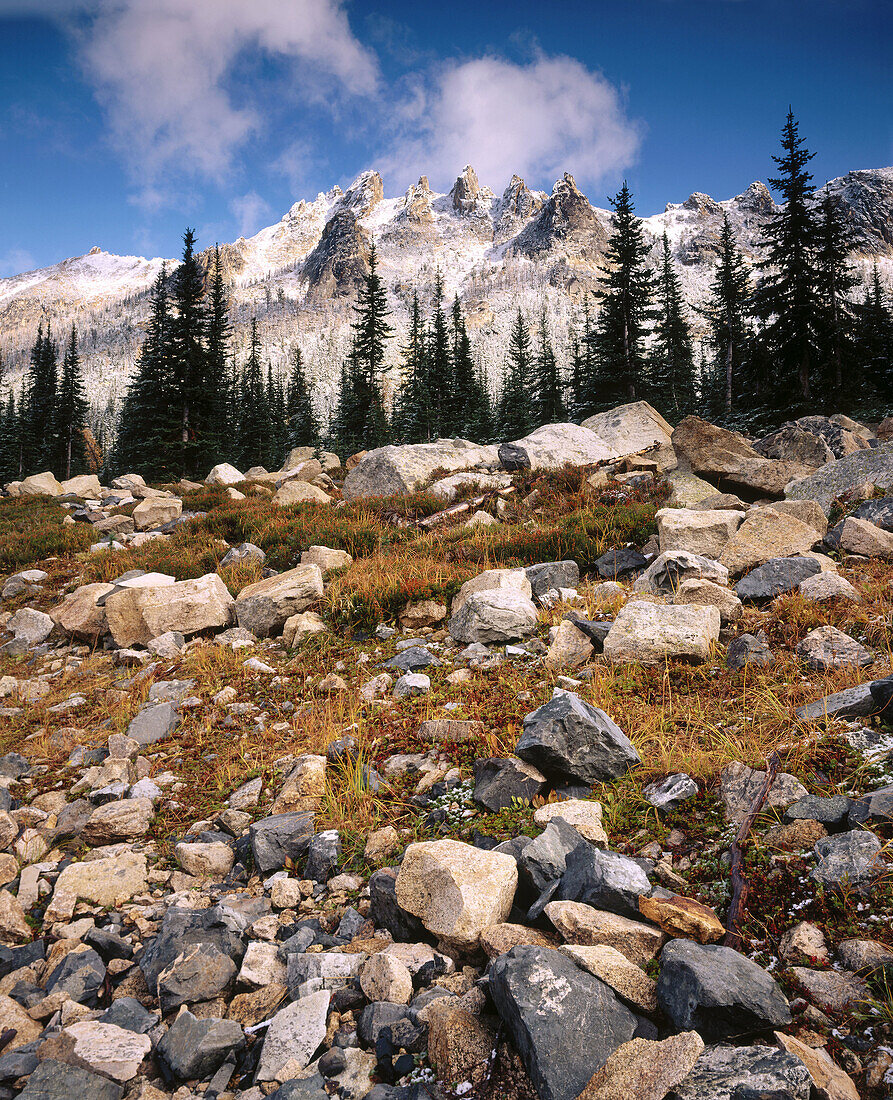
[666, 1044, 813, 1100]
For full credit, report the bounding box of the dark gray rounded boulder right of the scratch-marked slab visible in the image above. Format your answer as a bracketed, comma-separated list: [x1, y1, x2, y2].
[658, 939, 791, 1040]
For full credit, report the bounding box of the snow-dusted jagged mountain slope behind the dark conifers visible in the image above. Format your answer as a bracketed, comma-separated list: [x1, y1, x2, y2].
[0, 167, 893, 420]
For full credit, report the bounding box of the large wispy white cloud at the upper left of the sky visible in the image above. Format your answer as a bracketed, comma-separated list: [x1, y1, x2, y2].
[67, 0, 378, 193]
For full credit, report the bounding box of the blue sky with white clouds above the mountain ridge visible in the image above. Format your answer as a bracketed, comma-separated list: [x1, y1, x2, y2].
[0, 0, 893, 275]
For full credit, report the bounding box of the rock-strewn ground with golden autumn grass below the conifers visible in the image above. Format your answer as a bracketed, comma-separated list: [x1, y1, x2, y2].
[0, 405, 893, 1100]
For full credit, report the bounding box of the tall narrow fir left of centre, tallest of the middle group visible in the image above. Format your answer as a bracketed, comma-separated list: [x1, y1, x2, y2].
[330, 243, 394, 453]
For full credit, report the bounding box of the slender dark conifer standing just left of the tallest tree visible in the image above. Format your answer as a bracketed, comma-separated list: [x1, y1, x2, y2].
[702, 211, 750, 419]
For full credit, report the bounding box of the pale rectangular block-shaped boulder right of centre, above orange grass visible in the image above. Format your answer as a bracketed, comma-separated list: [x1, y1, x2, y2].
[605, 600, 720, 664]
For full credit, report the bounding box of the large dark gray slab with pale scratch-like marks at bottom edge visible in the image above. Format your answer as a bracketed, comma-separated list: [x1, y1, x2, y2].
[489, 947, 637, 1100]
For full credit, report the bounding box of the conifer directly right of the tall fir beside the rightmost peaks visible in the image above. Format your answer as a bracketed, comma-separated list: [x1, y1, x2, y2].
[649, 233, 695, 421]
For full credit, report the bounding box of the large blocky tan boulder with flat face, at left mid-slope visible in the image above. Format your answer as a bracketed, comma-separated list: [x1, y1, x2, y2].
[106, 573, 233, 648]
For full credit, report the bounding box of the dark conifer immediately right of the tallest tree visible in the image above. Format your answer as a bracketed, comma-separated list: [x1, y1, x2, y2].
[816, 194, 863, 413]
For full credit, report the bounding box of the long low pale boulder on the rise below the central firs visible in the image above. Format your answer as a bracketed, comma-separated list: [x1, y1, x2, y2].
[343, 439, 499, 501]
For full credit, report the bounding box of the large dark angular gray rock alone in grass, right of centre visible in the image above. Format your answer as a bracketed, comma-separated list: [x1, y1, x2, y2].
[515, 689, 640, 787]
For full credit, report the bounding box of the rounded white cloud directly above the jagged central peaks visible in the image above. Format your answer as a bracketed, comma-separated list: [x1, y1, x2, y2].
[383, 54, 640, 198]
